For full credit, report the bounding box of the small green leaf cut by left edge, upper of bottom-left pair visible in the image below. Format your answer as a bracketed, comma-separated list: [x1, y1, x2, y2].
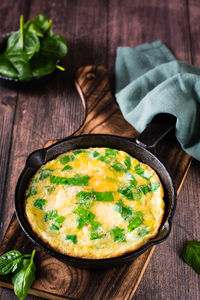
[0, 250, 23, 275]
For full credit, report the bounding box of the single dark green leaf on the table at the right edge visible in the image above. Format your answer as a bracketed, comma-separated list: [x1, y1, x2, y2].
[181, 241, 200, 274]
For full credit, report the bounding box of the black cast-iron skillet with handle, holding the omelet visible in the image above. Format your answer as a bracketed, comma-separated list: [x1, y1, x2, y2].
[15, 67, 176, 268]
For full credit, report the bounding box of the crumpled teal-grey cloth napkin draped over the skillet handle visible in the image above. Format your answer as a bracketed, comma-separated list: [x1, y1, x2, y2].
[115, 41, 200, 160]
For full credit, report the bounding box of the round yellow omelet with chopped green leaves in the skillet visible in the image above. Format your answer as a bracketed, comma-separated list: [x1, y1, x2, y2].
[24, 148, 165, 259]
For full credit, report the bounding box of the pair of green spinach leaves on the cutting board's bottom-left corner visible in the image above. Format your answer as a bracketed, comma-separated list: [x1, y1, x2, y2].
[0, 250, 36, 300]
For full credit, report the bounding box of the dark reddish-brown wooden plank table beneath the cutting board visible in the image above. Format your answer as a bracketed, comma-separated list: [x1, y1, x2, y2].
[0, 0, 200, 300]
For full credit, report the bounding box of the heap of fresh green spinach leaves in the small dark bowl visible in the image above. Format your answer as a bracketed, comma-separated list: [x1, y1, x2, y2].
[0, 14, 68, 81]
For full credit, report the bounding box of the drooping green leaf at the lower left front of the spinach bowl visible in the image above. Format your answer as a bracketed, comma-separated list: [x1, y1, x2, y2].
[5, 47, 32, 81]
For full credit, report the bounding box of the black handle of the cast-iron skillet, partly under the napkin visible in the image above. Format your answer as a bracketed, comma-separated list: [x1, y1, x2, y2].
[134, 114, 176, 150]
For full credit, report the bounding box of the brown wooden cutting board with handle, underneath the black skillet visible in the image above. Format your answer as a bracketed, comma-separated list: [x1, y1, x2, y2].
[0, 66, 191, 300]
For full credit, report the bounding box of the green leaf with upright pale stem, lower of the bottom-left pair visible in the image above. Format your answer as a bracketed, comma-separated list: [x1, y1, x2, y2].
[12, 250, 36, 300]
